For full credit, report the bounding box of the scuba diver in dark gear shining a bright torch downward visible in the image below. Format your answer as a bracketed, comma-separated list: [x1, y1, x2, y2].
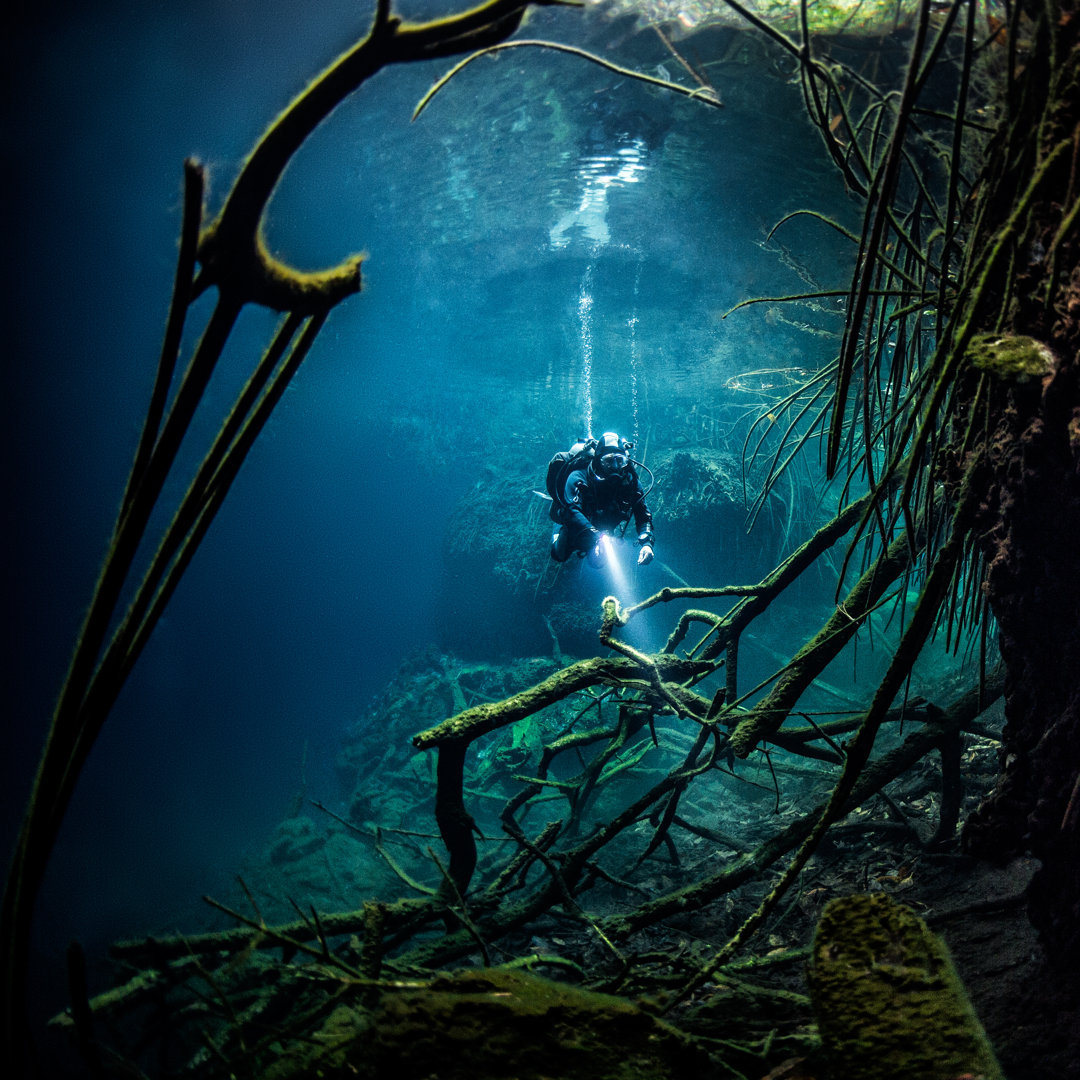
[548, 431, 652, 566]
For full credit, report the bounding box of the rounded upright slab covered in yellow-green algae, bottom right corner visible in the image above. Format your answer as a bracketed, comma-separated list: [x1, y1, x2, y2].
[807, 893, 1003, 1080]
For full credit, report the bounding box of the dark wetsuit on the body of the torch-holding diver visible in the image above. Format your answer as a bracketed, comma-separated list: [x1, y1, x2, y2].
[551, 463, 652, 563]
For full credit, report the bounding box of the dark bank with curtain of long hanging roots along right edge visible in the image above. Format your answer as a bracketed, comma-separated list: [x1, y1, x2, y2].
[734, 2, 1080, 959]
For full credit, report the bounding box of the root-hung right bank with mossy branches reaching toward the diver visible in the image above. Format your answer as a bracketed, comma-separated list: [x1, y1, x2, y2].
[401, 0, 1080, 1006]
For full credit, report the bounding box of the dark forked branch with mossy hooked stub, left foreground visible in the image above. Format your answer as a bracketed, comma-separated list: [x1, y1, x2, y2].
[0, 0, 587, 1061]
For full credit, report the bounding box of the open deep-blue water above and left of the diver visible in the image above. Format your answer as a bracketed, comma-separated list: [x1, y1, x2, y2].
[0, 0, 868, 1028]
